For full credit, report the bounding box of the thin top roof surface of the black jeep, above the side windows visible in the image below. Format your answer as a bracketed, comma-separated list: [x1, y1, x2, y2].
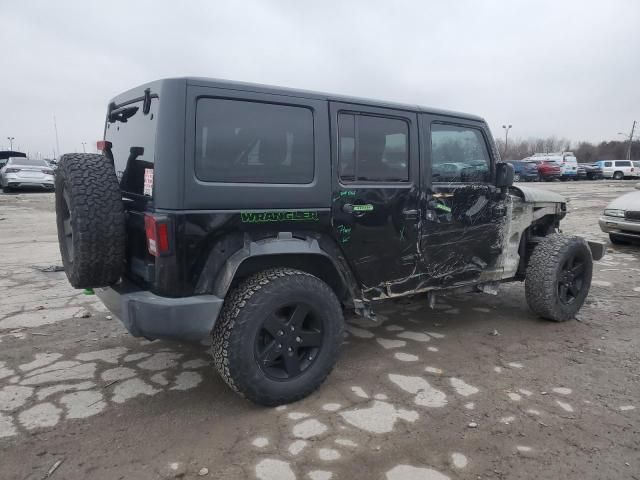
[114, 77, 484, 122]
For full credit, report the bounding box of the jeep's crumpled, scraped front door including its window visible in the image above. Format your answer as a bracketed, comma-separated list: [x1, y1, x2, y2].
[420, 115, 507, 287]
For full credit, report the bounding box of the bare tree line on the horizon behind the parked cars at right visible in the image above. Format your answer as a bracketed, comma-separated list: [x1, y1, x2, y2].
[496, 137, 640, 163]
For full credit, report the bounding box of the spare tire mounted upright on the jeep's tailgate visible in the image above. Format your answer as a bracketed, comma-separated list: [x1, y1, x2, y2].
[56, 153, 126, 288]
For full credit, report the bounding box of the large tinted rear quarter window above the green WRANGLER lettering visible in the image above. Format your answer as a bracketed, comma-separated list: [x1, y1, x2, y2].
[195, 98, 313, 184]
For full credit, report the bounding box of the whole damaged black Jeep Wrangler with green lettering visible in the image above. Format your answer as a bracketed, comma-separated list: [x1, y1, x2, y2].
[56, 78, 603, 405]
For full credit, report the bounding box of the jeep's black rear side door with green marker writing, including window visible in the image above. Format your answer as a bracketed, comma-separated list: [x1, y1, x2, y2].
[330, 103, 419, 298]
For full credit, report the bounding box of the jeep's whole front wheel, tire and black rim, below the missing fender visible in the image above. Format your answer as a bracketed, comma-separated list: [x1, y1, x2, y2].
[525, 233, 593, 322]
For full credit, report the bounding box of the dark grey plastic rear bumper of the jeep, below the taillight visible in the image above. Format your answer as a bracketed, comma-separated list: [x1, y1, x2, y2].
[95, 280, 224, 341]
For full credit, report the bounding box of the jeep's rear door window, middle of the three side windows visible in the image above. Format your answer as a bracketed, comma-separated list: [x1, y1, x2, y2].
[338, 113, 409, 182]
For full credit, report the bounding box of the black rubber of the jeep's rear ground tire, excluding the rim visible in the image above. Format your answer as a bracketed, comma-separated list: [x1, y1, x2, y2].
[212, 268, 344, 406]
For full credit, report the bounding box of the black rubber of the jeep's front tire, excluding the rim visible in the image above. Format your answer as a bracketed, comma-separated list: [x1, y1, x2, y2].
[525, 233, 593, 322]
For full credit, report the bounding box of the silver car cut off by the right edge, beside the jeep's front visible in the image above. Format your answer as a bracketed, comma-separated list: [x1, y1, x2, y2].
[599, 183, 640, 244]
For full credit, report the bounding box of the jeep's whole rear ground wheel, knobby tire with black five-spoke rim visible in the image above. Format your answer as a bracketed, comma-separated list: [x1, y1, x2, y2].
[212, 268, 344, 406]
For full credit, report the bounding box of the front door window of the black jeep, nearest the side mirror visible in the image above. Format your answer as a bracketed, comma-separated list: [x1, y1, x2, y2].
[431, 123, 491, 182]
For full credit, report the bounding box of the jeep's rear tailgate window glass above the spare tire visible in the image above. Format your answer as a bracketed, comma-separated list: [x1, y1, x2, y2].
[105, 96, 158, 195]
